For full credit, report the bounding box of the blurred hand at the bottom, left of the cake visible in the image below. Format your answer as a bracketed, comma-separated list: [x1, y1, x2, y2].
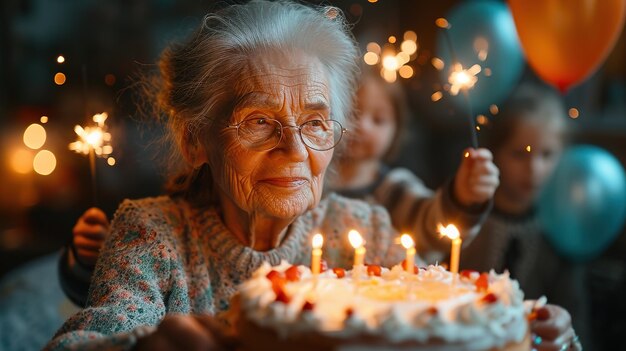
[134, 314, 235, 351]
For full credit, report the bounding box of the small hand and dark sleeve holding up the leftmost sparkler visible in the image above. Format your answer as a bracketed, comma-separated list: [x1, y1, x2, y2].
[59, 207, 109, 306]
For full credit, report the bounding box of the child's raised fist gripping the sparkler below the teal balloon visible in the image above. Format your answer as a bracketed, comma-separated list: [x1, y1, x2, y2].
[454, 149, 500, 206]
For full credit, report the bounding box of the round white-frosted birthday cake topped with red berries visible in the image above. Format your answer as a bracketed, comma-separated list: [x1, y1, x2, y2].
[233, 262, 530, 351]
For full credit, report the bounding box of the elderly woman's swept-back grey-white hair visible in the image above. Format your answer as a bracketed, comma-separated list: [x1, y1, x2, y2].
[160, 0, 358, 151]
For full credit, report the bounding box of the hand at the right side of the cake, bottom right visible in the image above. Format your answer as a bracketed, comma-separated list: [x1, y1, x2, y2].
[530, 304, 582, 351]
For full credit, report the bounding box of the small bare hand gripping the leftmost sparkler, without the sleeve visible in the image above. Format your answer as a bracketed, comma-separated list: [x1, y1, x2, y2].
[72, 207, 109, 266]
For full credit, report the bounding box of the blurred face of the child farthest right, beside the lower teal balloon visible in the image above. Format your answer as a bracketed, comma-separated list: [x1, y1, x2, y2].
[494, 120, 563, 208]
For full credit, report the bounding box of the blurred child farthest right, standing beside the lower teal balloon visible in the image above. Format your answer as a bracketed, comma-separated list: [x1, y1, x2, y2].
[460, 84, 589, 349]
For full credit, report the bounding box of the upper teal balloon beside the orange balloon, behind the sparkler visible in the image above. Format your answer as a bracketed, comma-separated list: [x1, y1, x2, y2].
[436, 1, 525, 114]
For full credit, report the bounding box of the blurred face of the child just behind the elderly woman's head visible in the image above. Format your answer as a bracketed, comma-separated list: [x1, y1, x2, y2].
[347, 79, 397, 161]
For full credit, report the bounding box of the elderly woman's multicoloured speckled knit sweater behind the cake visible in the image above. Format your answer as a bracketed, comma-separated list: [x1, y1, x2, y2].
[46, 194, 404, 350]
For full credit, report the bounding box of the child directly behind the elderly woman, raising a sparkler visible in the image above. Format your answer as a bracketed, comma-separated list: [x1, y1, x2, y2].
[328, 71, 498, 263]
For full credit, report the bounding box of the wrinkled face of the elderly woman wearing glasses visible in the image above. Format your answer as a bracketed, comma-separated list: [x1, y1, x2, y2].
[206, 53, 333, 219]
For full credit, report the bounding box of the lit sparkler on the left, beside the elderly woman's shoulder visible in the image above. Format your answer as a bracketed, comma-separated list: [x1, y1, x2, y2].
[69, 112, 113, 204]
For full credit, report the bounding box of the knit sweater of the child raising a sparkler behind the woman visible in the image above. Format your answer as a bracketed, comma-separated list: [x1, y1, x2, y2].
[330, 166, 492, 263]
